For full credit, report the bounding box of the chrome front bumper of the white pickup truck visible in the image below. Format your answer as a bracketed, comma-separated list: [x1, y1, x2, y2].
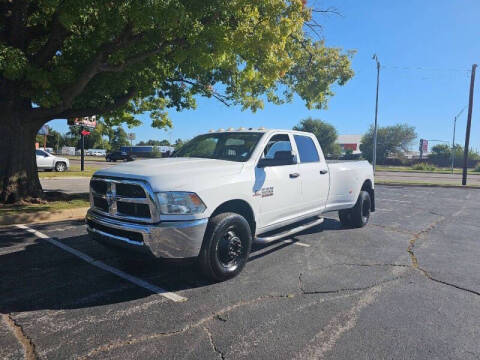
[85, 209, 208, 259]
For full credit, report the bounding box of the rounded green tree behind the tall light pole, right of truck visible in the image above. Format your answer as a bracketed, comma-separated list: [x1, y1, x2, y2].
[360, 124, 417, 164]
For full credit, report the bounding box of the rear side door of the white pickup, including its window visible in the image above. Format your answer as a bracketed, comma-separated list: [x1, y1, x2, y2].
[293, 134, 330, 212]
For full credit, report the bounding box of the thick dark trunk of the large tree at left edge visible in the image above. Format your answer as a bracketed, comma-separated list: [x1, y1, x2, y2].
[0, 109, 42, 203]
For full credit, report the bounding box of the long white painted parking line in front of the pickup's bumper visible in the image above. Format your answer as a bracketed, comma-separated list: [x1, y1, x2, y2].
[17, 225, 187, 302]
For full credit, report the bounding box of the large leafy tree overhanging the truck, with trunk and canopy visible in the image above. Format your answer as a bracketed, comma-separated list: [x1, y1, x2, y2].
[0, 0, 353, 202]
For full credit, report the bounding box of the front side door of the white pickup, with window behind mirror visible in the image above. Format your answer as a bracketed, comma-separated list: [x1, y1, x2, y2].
[253, 134, 300, 227]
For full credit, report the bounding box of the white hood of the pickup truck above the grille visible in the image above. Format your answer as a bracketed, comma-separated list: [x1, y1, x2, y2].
[94, 158, 244, 192]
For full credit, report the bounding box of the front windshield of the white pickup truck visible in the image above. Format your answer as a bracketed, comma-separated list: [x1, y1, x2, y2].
[172, 132, 263, 162]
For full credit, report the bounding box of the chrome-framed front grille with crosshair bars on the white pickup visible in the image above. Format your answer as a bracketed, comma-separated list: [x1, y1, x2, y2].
[90, 177, 160, 223]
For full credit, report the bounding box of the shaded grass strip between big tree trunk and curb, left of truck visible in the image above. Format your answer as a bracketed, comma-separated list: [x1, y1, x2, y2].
[0, 192, 90, 217]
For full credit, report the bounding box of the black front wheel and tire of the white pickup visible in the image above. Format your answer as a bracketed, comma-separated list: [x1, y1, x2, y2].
[198, 212, 252, 282]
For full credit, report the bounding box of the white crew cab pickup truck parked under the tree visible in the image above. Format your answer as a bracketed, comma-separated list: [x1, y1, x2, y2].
[86, 129, 375, 281]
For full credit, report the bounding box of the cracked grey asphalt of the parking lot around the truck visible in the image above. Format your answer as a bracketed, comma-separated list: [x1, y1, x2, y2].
[0, 186, 480, 359]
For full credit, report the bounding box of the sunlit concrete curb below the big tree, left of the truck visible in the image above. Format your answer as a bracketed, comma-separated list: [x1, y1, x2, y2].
[0, 207, 89, 226]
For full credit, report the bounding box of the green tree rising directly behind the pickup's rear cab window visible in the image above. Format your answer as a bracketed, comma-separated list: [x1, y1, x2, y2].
[293, 117, 342, 157]
